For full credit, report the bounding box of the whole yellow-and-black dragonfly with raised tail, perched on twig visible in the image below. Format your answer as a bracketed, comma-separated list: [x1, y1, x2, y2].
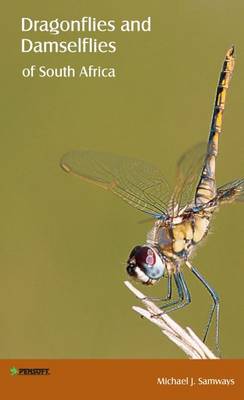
[60, 46, 244, 351]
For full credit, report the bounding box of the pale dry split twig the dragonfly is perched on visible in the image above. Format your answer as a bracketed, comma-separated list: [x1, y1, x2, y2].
[124, 281, 218, 359]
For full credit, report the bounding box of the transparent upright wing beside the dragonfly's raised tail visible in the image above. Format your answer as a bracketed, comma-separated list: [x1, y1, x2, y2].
[169, 143, 207, 215]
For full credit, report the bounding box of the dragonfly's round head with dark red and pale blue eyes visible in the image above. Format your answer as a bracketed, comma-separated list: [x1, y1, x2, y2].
[126, 245, 165, 285]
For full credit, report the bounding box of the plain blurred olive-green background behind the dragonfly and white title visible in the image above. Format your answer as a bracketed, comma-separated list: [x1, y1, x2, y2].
[0, 0, 244, 358]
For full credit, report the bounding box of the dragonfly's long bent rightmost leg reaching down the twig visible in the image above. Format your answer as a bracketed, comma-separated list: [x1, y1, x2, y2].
[186, 261, 220, 353]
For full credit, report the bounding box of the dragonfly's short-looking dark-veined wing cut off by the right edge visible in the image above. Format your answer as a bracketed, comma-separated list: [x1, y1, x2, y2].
[217, 178, 244, 203]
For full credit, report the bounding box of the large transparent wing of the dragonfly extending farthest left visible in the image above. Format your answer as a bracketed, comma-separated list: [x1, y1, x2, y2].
[61, 150, 170, 217]
